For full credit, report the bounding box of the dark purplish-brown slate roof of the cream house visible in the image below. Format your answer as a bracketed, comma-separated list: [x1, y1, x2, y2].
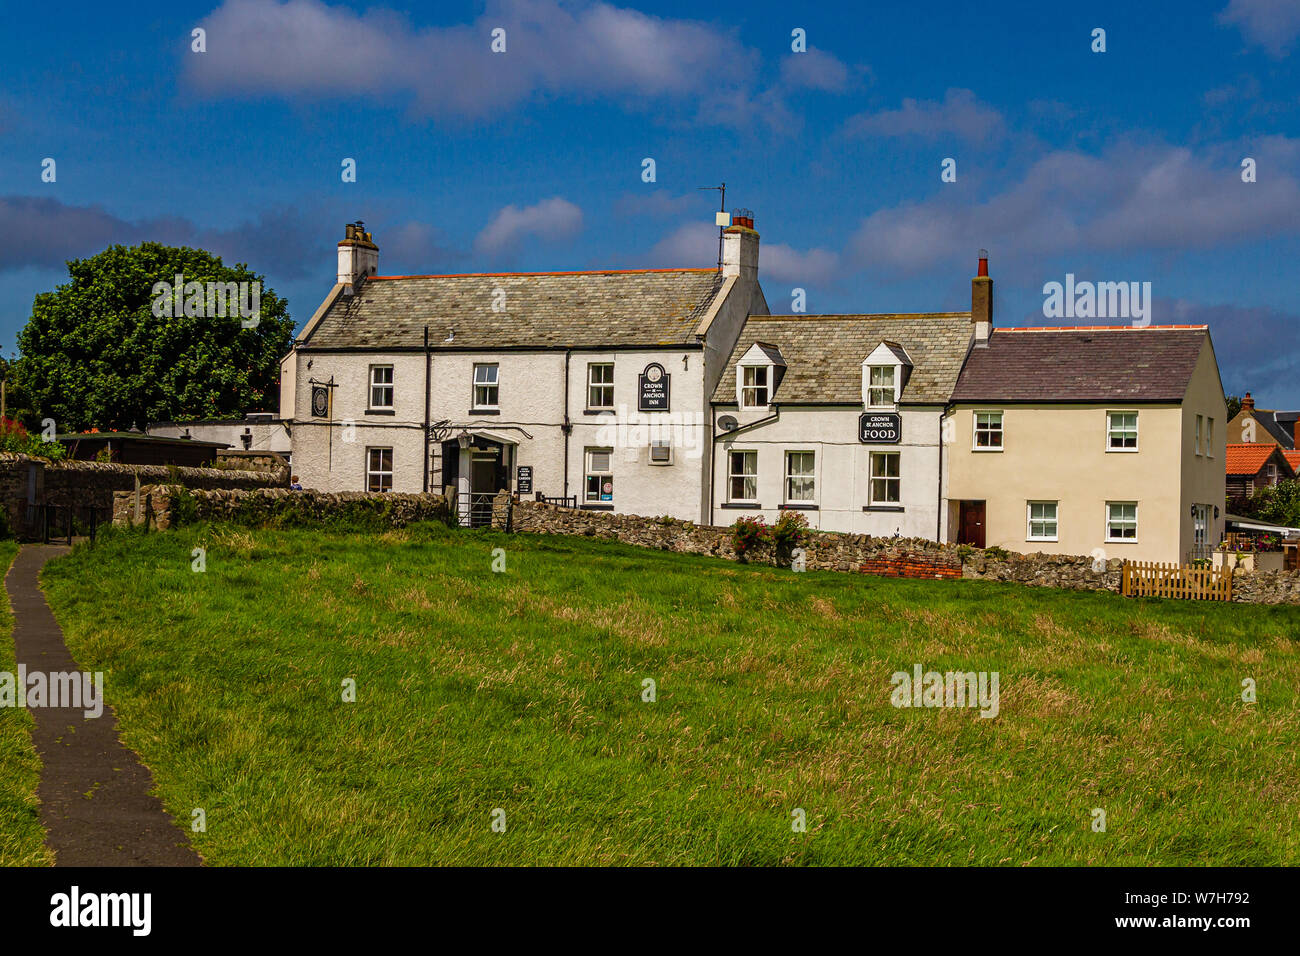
[953, 325, 1206, 402]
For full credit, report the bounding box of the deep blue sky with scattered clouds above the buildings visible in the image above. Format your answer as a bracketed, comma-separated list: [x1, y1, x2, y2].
[0, 0, 1300, 408]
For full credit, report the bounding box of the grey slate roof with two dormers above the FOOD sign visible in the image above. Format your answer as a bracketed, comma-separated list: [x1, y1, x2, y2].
[712, 312, 971, 405]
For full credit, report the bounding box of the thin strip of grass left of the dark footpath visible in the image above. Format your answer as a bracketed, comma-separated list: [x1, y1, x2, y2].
[0, 541, 53, 866]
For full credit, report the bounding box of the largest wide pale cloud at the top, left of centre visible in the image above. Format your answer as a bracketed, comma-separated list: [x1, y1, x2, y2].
[186, 0, 757, 118]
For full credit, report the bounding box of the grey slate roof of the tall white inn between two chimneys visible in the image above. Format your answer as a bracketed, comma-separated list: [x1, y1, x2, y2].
[300, 269, 723, 349]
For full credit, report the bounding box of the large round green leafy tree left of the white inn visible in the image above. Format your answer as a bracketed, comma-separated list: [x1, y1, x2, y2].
[16, 242, 293, 432]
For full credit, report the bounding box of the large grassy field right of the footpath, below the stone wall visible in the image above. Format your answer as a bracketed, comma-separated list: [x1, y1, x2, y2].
[35, 525, 1300, 865]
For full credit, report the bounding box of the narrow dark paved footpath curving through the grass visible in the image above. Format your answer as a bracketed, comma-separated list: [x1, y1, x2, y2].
[5, 545, 199, 866]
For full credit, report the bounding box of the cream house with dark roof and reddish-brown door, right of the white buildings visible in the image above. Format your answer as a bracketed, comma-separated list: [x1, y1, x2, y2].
[945, 314, 1227, 563]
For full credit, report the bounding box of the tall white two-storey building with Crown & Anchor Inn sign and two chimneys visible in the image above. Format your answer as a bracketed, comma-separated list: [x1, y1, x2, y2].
[281, 219, 767, 523]
